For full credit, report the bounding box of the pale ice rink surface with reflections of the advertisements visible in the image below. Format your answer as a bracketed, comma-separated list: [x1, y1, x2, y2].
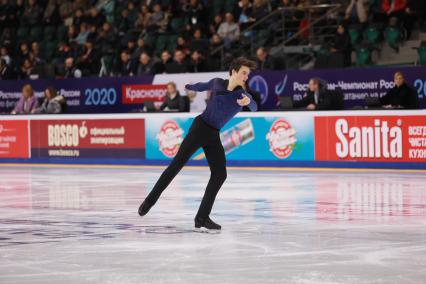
[0, 165, 426, 284]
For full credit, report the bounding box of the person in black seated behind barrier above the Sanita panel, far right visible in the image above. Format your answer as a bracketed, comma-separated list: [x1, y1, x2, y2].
[380, 72, 419, 109]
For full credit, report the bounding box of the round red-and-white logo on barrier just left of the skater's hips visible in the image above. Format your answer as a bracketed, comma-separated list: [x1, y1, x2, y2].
[157, 120, 183, 158]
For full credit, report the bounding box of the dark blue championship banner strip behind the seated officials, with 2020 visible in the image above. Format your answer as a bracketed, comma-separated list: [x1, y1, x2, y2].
[0, 67, 426, 114]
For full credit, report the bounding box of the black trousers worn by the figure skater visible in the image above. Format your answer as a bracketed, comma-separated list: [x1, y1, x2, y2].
[146, 116, 227, 218]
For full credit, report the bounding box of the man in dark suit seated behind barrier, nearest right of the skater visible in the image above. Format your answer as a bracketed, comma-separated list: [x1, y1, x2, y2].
[293, 78, 335, 110]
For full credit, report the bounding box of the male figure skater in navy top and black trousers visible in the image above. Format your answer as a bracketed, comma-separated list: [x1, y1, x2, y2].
[139, 57, 257, 230]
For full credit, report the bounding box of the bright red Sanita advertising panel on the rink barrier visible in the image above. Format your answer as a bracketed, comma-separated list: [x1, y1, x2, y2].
[315, 116, 426, 162]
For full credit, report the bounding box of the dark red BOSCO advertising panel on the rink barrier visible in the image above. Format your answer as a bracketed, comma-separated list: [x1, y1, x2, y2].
[31, 119, 145, 158]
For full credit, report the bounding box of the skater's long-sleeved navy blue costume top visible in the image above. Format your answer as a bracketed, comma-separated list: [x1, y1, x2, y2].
[185, 78, 257, 129]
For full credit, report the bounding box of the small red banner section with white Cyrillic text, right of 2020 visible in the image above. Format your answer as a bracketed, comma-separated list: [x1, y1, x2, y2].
[122, 85, 167, 105]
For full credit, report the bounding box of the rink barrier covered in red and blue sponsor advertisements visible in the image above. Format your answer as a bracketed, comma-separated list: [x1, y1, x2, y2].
[0, 110, 426, 169]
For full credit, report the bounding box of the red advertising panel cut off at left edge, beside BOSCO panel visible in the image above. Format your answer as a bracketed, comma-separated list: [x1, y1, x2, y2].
[0, 120, 30, 158]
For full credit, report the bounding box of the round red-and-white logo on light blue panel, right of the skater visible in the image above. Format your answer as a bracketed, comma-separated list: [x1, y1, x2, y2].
[266, 118, 297, 159]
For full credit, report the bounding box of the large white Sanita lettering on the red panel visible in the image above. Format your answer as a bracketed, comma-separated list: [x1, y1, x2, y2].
[335, 118, 402, 158]
